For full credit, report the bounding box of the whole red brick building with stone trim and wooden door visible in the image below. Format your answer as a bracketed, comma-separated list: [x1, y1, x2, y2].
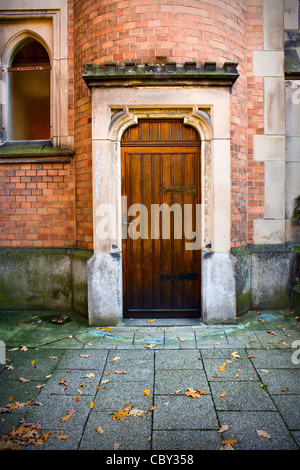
[0, 0, 300, 325]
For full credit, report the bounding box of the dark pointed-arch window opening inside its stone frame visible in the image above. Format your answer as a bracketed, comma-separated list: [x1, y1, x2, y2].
[8, 38, 50, 140]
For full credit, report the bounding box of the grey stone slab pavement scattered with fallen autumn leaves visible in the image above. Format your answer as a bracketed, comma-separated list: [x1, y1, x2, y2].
[0, 311, 300, 455]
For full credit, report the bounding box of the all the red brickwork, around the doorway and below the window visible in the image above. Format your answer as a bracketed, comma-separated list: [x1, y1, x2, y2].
[0, 0, 264, 248]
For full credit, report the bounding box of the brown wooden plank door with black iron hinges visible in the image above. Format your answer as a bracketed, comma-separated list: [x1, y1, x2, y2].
[121, 120, 201, 318]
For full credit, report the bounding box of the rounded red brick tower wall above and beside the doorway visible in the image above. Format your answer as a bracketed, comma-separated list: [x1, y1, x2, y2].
[74, 0, 247, 247]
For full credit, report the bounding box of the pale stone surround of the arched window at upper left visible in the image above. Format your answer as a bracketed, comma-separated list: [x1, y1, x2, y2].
[0, 0, 73, 149]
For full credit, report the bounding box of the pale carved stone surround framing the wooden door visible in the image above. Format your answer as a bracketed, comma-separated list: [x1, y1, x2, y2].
[88, 86, 236, 326]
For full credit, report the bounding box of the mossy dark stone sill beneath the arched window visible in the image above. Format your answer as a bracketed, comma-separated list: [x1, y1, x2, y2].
[0, 141, 74, 164]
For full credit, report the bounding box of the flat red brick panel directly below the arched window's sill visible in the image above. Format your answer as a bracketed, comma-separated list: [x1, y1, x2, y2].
[0, 163, 75, 247]
